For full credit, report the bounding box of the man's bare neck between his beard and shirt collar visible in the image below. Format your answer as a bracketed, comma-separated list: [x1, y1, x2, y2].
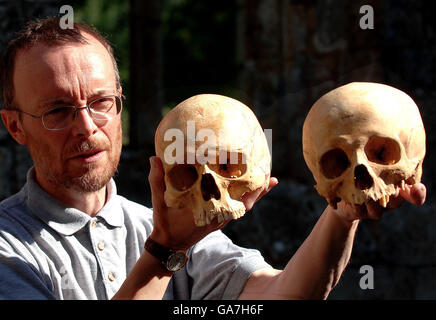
[35, 174, 107, 217]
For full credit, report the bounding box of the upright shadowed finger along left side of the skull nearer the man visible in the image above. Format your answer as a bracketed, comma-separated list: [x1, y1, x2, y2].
[148, 156, 166, 210]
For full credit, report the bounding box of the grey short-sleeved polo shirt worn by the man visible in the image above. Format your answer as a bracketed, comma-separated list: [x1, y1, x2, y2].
[0, 169, 269, 300]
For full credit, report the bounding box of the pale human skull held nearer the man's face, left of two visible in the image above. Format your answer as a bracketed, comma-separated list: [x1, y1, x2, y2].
[155, 94, 271, 226]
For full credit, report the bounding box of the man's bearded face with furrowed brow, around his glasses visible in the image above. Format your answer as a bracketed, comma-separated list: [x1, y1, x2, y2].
[13, 37, 122, 192]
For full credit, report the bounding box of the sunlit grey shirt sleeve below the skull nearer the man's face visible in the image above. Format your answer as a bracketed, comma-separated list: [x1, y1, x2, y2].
[172, 230, 271, 300]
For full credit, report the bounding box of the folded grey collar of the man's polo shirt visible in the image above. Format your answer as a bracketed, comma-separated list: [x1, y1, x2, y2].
[25, 168, 124, 235]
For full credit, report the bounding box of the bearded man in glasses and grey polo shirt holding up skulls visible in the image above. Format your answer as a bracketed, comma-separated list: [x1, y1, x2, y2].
[0, 19, 426, 299]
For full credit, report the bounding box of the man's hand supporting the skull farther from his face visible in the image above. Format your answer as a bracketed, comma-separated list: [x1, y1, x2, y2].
[336, 183, 427, 221]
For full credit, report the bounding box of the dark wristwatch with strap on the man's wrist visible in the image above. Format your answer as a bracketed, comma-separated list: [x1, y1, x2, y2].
[144, 237, 188, 272]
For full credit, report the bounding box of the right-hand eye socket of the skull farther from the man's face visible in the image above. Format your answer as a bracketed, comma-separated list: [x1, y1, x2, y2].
[365, 136, 401, 165]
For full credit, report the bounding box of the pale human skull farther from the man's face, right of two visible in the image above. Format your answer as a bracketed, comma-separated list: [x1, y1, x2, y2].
[303, 82, 425, 208]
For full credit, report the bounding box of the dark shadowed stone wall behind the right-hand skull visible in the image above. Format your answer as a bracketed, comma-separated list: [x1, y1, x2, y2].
[227, 0, 436, 299]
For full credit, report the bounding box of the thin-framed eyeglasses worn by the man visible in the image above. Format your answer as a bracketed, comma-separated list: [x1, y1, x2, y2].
[15, 95, 124, 130]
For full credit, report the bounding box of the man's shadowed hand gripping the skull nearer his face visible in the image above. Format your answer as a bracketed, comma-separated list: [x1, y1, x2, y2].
[148, 156, 278, 251]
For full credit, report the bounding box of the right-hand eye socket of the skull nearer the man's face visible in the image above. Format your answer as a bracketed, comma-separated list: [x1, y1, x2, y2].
[209, 152, 247, 179]
